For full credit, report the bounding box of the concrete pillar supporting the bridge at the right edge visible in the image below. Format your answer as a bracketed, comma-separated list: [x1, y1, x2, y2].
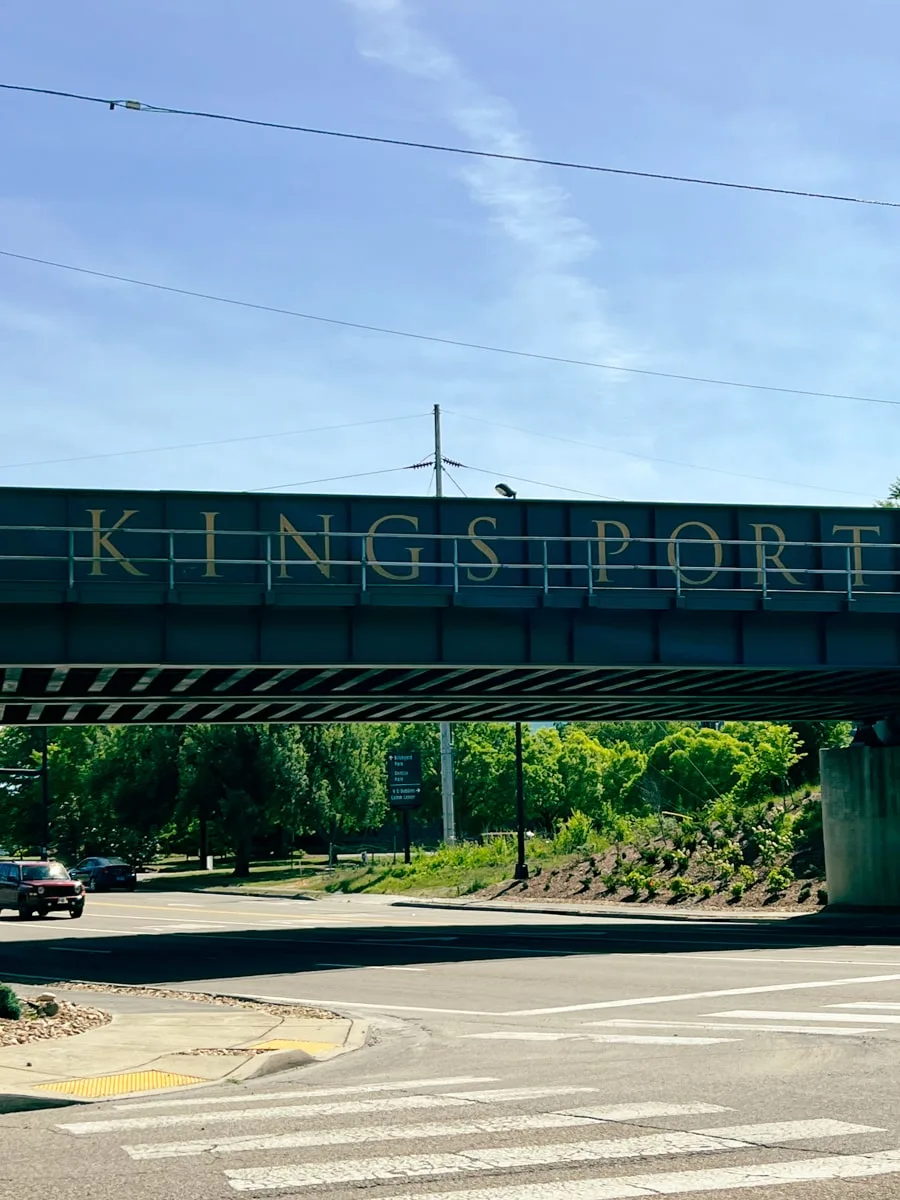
[821, 745, 900, 908]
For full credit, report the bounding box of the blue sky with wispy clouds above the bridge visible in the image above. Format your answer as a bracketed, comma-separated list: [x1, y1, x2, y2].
[0, 0, 900, 504]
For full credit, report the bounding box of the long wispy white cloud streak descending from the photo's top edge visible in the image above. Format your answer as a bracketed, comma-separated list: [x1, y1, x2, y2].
[346, 0, 631, 367]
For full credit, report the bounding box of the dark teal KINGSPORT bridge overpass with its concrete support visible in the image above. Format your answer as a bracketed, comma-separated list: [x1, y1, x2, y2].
[0, 488, 900, 906]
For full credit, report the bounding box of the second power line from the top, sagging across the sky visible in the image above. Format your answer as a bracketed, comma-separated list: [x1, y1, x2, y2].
[0, 250, 900, 408]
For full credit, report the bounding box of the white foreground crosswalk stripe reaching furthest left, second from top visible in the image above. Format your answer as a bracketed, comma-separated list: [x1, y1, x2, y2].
[56, 1087, 598, 1136]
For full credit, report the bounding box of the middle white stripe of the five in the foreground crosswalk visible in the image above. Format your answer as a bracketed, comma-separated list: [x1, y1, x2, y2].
[122, 1103, 728, 1159]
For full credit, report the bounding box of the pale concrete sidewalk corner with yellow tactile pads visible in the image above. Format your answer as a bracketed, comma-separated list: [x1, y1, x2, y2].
[0, 989, 367, 1114]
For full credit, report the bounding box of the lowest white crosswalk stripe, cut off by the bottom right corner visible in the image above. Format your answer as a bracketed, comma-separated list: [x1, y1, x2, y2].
[385, 1150, 900, 1200]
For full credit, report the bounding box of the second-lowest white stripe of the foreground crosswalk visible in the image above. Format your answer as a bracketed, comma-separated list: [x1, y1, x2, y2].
[224, 1121, 872, 1192]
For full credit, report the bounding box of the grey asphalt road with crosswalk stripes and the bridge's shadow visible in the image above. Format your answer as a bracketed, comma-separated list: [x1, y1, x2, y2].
[0, 892, 900, 1200]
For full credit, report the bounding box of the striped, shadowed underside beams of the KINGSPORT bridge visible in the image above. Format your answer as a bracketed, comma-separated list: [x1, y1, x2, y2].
[0, 664, 900, 725]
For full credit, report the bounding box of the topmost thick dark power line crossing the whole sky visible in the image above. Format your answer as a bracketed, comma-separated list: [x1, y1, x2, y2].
[0, 83, 900, 209]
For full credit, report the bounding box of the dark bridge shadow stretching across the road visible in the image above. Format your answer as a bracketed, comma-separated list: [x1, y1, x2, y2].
[0, 913, 900, 985]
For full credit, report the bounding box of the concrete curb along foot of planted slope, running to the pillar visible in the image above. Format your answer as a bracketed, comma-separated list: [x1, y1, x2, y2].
[392, 898, 900, 934]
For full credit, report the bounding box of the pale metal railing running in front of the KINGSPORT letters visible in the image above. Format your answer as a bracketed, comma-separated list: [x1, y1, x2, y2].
[0, 526, 900, 600]
